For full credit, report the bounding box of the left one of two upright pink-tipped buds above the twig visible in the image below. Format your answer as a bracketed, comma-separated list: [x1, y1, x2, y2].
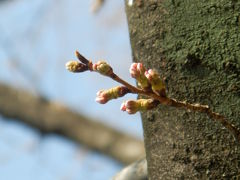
[129, 63, 149, 89]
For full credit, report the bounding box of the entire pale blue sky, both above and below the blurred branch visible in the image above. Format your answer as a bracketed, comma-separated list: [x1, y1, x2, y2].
[0, 0, 142, 179]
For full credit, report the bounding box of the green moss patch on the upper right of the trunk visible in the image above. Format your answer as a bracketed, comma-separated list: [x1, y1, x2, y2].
[163, 0, 240, 73]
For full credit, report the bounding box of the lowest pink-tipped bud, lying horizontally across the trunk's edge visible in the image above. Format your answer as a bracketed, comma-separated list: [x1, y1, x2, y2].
[120, 99, 159, 114]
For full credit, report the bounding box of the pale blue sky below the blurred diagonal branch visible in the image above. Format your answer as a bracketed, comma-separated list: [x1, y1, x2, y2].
[0, 117, 122, 180]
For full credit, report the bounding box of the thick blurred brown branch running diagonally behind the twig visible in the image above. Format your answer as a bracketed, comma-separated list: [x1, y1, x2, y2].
[0, 84, 144, 164]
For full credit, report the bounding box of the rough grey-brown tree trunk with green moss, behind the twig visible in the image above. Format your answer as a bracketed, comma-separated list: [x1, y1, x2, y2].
[125, 0, 240, 180]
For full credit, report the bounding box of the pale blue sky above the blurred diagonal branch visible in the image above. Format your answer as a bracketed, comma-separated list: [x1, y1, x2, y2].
[0, 0, 142, 137]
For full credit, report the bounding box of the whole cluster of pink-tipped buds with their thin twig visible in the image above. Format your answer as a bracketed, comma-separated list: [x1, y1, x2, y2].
[66, 51, 166, 114]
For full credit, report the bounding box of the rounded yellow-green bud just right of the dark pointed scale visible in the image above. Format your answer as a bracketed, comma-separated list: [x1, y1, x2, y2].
[92, 61, 113, 76]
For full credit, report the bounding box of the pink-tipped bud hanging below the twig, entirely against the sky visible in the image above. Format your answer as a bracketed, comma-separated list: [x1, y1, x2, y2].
[95, 86, 130, 104]
